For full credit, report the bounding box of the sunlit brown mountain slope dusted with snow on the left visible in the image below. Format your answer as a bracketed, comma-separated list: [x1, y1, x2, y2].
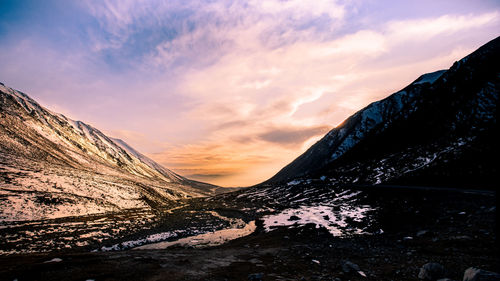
[0, 84, 218, 220]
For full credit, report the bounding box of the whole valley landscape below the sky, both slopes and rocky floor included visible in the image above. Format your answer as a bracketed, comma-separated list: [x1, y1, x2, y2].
[0, 32, 500, 281]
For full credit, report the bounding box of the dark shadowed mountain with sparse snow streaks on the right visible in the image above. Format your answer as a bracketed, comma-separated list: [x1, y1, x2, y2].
[263, 37, 500, 188]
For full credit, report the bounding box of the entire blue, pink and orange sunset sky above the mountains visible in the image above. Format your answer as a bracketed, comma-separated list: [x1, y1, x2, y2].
[0, 0, 500, 186]
